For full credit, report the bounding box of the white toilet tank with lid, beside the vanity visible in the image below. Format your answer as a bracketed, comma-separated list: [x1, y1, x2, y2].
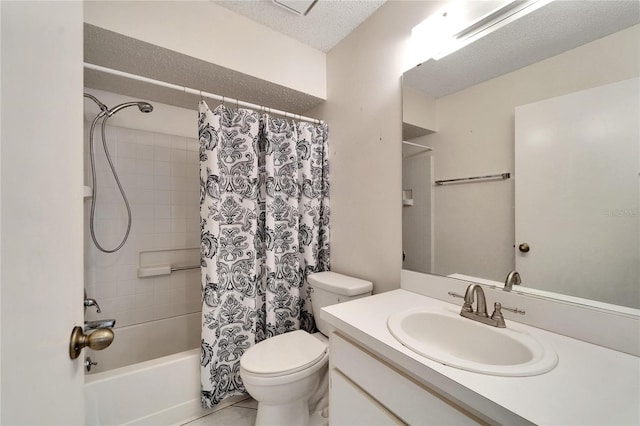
[307, 271, 373, 336]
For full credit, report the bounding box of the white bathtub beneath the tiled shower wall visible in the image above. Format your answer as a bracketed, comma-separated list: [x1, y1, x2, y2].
[84, 312, 246, 426]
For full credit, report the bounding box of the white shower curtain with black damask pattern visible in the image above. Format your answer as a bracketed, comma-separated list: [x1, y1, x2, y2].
[198, 101, 329, 408]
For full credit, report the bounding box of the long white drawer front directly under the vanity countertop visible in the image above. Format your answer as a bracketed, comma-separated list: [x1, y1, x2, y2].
[330, 333, 481, 425]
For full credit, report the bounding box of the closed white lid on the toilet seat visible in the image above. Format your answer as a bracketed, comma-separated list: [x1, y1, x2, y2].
[240, 330, 327, 375]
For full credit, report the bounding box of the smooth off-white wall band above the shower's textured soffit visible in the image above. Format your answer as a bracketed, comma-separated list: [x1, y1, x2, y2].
[84, 1, 327, 99]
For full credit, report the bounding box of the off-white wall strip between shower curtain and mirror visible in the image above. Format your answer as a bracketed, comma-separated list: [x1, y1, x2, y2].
[310, 1, 437, 293]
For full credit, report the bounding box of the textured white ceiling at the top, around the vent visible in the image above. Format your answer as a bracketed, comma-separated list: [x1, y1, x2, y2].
[214, 0, 386, 52]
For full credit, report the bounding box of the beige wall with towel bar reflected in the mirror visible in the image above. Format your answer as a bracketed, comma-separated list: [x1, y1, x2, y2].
[418, 26, 640, 281]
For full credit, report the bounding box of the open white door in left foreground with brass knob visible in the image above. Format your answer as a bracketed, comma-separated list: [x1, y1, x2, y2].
[0, 1, 84, 425]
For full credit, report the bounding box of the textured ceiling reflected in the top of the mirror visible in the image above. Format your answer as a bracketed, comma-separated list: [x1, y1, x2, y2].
[403, 0, 640, 98]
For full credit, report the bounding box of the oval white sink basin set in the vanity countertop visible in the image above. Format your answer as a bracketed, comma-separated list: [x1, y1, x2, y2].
[387, 308, 558, 376]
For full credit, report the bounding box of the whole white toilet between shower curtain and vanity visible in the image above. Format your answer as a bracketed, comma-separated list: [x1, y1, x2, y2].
[240, 271, 373, 426]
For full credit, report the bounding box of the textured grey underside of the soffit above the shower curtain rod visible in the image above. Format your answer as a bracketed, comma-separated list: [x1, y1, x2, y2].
[84, 24, 323, 115]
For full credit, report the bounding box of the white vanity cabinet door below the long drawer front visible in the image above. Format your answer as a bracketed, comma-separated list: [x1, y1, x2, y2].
[329, 370, 404, 426]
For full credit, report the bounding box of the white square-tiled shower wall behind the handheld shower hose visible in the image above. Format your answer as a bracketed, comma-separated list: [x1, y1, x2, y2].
[85, 123, 201, 327]
